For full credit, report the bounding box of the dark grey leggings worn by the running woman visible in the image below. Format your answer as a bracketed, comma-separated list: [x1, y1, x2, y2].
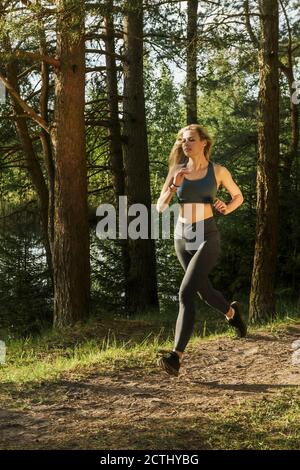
[174, 217, 230, 352]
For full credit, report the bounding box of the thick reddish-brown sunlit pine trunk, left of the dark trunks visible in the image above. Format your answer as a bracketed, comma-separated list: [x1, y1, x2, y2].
[51, 0, 90, 327]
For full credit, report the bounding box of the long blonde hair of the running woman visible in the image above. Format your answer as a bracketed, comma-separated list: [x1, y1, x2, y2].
[169, 124, 213, 169]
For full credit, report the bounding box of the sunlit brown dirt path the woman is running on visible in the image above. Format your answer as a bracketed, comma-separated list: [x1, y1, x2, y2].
[0, 326, 300, 449]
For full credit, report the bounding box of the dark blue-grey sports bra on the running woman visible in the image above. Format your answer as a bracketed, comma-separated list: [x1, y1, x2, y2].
[176, 161, 218, 204]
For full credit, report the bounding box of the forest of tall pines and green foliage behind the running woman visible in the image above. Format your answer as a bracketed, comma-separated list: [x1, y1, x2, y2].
[0, 0, 300, 449]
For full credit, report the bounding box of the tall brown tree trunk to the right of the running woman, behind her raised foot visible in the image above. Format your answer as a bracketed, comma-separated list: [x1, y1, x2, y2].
[249, 0, 279, 322]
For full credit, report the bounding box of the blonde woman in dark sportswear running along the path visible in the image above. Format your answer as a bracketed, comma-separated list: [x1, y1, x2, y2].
[156, 124, 247, 376]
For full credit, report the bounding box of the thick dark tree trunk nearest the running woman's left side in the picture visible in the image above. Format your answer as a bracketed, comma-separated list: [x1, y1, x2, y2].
[124, 0, 158, 312]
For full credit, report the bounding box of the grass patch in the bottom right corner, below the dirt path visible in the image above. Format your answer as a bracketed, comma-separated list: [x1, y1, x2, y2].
[204, 389, 300, 450]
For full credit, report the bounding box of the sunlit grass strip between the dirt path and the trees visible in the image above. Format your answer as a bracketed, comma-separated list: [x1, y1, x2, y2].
[0, 304, 299, 385]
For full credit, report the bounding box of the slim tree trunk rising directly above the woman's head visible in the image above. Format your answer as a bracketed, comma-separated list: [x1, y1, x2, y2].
[186, 0, 198, 124]
